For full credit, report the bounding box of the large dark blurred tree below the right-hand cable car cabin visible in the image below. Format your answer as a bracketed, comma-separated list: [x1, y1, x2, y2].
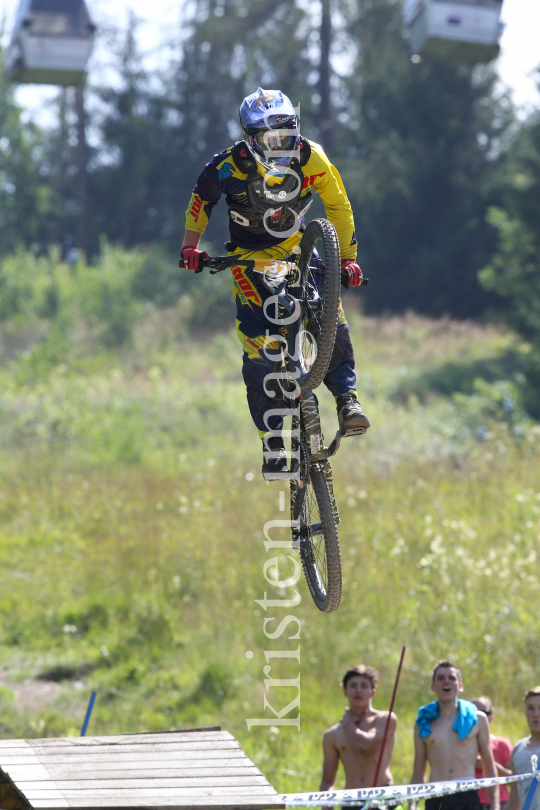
[338, 0, 512, 317]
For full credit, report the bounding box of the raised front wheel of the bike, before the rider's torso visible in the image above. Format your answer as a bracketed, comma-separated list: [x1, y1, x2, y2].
[294, 219, 341, 391]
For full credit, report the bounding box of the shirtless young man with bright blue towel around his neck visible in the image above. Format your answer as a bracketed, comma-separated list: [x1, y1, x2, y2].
[409, 661, 499, 810]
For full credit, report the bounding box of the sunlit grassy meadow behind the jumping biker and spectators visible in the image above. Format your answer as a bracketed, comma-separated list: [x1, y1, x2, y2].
[0, 253, 540, 791]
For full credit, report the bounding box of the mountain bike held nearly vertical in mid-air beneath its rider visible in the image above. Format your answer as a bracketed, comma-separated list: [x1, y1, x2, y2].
[180, 219, 368, 613]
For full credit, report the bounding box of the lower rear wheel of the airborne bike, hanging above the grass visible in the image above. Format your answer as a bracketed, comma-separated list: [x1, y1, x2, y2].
[291, 420, 341, 613]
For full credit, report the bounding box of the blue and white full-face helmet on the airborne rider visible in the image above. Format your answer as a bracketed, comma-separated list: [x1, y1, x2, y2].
[240, 87, 299, 166]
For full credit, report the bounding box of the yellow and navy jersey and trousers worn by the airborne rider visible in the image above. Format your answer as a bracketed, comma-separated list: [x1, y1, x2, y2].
[186, 141, 357, 435]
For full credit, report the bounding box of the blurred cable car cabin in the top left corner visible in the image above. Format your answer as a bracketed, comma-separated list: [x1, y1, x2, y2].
[6, 0, 96, 87]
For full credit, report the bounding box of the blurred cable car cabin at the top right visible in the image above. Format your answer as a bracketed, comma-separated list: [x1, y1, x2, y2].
[403, 0, 503, 63]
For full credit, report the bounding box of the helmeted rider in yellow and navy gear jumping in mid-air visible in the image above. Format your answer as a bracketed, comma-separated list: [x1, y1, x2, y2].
[182, 87, 370, 480]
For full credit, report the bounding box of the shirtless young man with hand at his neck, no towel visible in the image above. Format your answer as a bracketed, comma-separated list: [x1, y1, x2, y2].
[320, 664, 397, 790]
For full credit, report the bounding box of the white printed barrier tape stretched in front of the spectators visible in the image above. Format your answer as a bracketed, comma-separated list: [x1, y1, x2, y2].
[279, 770, 540, 807]
